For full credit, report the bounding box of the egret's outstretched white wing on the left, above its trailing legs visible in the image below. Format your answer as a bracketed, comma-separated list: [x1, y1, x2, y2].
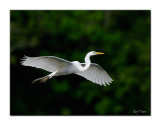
[21, 56, 71, 72]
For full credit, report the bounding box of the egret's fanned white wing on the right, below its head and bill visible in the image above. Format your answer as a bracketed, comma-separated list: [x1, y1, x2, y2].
[76, 63, 113, 86]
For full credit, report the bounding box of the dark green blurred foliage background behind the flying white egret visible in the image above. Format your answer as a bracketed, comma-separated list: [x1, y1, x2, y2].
[10, 10, 151, 115]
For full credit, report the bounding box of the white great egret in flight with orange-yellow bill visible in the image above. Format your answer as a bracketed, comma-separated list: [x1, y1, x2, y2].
[21, 51, 113, 86]
